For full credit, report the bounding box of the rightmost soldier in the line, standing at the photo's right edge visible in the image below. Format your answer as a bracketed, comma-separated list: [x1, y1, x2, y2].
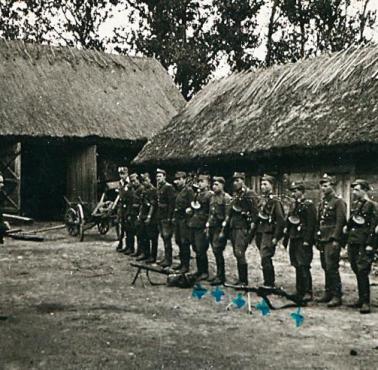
[344, 179, 377, 313]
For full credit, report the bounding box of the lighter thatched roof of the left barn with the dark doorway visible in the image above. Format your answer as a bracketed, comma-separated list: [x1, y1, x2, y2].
[0, 40, 185, 140]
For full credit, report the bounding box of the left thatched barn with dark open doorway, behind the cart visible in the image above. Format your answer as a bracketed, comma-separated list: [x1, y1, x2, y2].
[0, 41, 185, 218]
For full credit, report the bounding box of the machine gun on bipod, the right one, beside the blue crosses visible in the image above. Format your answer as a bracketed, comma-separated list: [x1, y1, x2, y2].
[224, 283, 305, 313]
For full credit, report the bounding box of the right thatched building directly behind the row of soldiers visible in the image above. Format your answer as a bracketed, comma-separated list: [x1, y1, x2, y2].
[135, 46, 378, 211]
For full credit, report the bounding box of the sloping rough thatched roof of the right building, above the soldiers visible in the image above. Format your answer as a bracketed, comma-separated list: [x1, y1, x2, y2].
[136, 46, 378, 164]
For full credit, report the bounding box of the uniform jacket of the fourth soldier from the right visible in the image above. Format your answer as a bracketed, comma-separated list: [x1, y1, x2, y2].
[256, 194, 285, 240]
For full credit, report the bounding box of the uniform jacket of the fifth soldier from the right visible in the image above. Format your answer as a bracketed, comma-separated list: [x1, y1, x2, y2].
[229, 188, 257, 229]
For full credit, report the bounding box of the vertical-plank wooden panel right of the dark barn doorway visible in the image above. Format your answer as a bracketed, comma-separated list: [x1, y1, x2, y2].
[67, 145, 97, 205]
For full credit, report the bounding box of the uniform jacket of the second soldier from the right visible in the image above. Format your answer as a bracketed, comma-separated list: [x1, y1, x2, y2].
[318, 194, 346, 242]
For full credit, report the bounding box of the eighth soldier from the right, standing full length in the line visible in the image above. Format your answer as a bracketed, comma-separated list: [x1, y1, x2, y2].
[173, 171, 194, 273]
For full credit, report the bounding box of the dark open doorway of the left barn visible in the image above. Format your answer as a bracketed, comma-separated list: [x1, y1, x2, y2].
[21, 143, 67, 220]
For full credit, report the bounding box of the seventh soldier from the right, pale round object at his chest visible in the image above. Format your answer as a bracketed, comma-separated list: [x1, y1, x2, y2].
[187, 174, 211, 281]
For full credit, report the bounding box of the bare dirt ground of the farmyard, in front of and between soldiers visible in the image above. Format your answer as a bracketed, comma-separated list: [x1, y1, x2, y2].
[0, 224, 378, 369]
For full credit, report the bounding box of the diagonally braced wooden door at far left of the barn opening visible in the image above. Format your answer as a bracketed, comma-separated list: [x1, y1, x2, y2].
[0, 140, 21, 213]
